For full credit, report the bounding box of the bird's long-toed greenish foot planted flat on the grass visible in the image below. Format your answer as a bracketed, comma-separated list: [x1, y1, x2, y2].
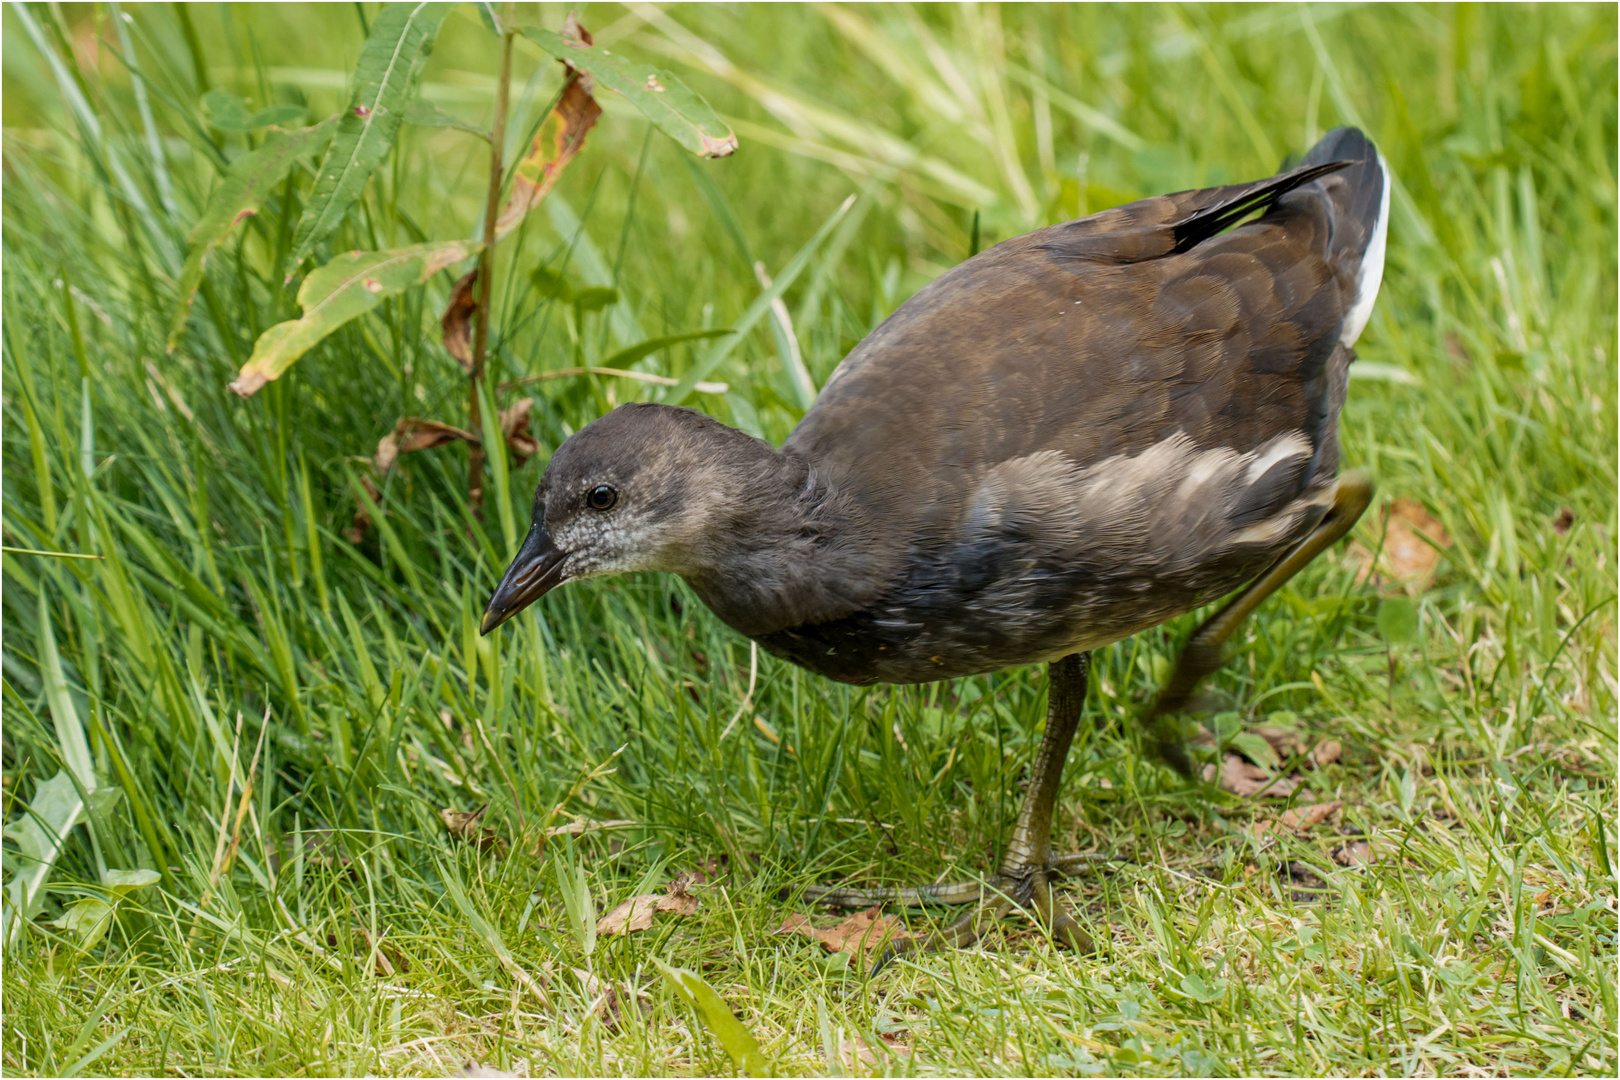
[793, 852, 1106, 973]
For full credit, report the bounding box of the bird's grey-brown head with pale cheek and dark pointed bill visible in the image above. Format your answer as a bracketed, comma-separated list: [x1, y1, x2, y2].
[481, 405, 774, 633]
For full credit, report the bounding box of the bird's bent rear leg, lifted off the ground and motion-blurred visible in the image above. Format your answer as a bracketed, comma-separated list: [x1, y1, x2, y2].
[1145, 471, 1372, 776]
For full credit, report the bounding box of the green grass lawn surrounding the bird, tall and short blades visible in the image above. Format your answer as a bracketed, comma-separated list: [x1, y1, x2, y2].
[0, 5, 1617, 1075]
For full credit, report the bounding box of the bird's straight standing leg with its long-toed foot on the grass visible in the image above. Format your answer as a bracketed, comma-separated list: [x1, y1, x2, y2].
[805, 653, 1092, 962]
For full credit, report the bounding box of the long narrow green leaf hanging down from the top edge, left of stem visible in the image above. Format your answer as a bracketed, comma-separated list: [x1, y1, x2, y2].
[293, 3, 450, 266]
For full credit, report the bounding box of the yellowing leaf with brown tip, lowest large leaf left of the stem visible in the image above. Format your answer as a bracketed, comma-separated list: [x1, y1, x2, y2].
[230, 240, 483, 397]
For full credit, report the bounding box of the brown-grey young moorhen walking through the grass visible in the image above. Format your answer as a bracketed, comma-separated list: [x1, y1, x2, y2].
[481, 128, 1392, 950]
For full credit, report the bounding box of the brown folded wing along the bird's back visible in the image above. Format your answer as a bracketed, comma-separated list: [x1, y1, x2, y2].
[787, 162, 1356, 559]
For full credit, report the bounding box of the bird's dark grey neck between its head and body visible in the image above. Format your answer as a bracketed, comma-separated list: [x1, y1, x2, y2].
[682, 450, 876, 636]
